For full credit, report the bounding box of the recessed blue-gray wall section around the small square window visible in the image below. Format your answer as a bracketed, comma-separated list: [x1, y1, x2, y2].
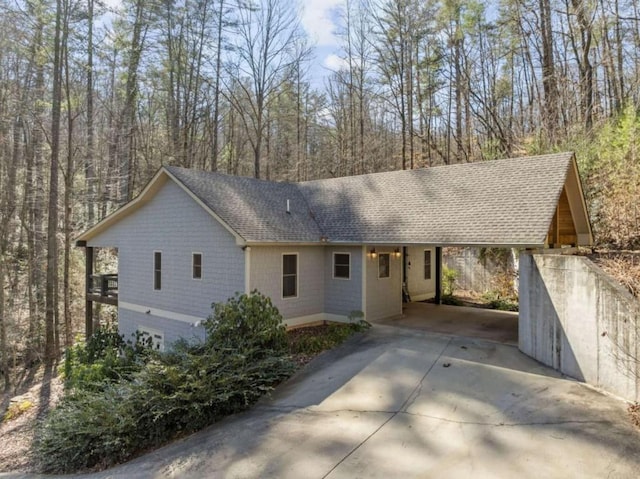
[324, 246, 364, 316]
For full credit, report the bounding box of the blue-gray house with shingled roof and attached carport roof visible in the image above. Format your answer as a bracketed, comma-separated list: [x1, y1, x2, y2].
[77, 152, 592, 349]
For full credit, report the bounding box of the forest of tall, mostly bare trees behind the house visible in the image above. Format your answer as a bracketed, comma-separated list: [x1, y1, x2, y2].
[0, 0, 640, 387]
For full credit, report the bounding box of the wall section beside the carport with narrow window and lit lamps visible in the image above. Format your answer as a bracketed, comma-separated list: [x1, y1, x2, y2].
[365, 245, 402, 321]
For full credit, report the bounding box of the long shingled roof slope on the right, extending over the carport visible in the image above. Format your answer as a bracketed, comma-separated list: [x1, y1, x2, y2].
[300, 153, 573, 245]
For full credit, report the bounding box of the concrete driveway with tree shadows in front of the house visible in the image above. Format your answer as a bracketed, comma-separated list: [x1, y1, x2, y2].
[5, 325, 640, 479]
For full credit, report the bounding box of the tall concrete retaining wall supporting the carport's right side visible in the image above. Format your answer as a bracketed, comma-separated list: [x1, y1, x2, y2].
[518, 253, 640, 401]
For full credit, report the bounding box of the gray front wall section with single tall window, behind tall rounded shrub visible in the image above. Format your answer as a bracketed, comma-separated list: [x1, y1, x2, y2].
[249, 245, 325, 324]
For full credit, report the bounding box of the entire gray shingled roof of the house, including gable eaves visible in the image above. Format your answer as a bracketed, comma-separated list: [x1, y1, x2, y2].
[78, 153, 591, 247]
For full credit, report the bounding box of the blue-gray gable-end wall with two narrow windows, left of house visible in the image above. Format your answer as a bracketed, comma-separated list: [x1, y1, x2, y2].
[89, 181, 245, 338]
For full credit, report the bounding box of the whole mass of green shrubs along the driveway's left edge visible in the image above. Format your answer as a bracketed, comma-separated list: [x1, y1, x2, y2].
[35, 292, 295, 473]
